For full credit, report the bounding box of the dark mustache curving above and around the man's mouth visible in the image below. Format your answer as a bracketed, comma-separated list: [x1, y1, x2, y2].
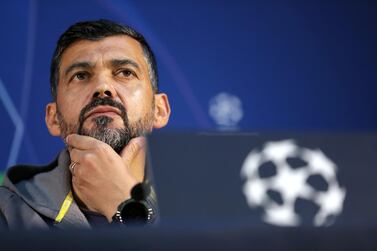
[79, 98, 128, 131]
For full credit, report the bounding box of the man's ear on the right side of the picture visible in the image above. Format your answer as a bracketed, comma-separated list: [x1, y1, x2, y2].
[153, 93, 170, 128]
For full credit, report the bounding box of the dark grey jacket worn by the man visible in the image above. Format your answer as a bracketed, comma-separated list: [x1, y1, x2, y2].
[0, 150, 157, 229]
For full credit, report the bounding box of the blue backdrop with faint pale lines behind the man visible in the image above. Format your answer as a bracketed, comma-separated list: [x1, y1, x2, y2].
[0, 0, 377, 171]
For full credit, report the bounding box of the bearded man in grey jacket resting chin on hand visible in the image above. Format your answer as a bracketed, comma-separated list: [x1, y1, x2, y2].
[0, 20, 170, 229]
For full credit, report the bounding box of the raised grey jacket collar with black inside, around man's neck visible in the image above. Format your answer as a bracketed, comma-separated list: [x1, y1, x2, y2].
[4, 149, 90, 228]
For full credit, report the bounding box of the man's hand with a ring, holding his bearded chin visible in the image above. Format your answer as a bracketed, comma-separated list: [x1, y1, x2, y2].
[66, 134, 145, 221]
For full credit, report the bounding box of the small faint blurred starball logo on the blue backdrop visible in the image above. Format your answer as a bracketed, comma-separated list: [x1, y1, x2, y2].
[209, 92, 243, 128]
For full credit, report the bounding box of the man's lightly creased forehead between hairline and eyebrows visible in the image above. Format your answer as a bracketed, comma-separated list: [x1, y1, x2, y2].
[60, 35, 147, 70]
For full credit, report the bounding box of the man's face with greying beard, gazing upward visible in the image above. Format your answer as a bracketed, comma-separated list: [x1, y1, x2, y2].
[52, 35, 154, 152]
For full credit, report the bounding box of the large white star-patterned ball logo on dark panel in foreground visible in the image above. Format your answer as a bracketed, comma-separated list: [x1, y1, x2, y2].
[241, 140, 346, 226]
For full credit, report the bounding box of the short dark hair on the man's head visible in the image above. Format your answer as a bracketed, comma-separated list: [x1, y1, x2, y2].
[50, 19, 158, 100]
